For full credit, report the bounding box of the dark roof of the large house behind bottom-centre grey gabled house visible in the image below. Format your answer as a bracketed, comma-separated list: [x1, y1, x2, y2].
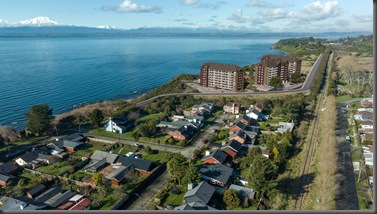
[198, 163, 233, 184]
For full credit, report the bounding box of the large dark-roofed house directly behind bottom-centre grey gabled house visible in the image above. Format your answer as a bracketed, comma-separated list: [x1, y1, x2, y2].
[197, 163, 233, 188]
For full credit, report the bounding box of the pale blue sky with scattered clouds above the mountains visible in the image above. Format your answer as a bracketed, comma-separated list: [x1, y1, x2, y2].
[0, 0, 373, 32]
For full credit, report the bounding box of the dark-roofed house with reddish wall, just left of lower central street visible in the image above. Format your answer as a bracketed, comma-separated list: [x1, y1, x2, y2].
[117, 155, 156, 175]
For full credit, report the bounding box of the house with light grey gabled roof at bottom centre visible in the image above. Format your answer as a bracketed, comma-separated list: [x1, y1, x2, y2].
[183, 181, 216, 205]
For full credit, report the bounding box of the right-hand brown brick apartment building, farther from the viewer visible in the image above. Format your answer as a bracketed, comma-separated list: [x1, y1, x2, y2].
[255, 55, 301, 86]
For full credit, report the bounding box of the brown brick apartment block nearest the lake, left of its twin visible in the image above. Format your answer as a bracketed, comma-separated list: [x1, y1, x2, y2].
[200, 62, 244, 91]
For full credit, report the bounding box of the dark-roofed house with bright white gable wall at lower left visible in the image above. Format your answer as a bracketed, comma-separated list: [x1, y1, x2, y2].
[16, 150, 59, 169]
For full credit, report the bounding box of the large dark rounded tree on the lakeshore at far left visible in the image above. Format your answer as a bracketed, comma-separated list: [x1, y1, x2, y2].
[25, 104, 54, 135]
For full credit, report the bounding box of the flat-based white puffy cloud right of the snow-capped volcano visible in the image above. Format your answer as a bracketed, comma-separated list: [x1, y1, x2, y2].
[102, 0, 162, 13]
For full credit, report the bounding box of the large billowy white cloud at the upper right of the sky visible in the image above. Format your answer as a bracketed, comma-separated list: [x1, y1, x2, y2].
[288, 1, 341, 21]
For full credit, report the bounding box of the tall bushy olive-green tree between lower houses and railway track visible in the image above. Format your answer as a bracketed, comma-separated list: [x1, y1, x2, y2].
[247, 155, 277, 207]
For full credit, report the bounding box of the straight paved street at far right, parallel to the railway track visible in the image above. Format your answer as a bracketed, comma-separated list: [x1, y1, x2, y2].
[335, 99, 361, 210]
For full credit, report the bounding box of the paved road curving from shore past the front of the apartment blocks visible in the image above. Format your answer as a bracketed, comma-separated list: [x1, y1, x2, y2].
[136, 54, 323, 107]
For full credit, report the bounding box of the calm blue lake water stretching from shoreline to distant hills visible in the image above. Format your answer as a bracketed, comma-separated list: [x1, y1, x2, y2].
[0, 35, 294, 129]
